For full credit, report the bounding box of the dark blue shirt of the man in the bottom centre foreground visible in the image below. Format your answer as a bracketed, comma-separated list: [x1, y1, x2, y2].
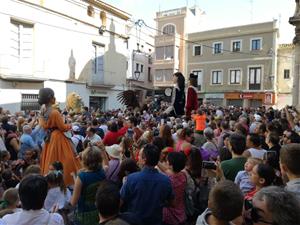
[121, 167, 173, 225]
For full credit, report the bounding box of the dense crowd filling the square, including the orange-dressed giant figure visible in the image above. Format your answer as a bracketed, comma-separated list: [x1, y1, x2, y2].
[0, 85, 300, 225]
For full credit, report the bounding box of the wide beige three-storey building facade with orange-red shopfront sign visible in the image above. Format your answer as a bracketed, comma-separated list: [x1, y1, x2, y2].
[186, 21, 278, 107]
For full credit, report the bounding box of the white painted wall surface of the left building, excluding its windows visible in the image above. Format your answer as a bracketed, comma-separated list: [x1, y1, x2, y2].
[0, 0, 128, 111]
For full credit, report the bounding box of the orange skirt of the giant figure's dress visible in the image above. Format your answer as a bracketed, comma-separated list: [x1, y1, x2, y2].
[40, 130, 81, 186]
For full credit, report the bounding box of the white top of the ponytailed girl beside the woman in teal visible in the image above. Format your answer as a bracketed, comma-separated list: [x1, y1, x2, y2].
[44, 187, 71, 211]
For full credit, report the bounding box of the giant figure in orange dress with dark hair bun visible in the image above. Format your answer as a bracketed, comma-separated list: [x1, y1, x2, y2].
[39, 88, 81, 186]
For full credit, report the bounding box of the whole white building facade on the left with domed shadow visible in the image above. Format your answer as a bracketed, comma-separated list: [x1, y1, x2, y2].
[0, 0, 130, 111]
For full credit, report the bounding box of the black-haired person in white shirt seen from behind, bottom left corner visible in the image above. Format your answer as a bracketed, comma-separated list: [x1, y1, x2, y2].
[0, 175, 64, 225]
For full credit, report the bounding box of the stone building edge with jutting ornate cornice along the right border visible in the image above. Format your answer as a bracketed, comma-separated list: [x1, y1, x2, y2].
[289, 0, 300, 108]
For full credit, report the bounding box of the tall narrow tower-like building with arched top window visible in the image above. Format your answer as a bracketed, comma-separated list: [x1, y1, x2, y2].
[154, 6, 204, 89]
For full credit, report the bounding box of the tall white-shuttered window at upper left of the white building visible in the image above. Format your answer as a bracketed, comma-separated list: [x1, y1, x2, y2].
[10, 20, 33, 73]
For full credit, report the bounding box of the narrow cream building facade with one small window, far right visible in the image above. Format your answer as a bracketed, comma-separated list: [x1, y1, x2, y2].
[277, 44, 295, 108]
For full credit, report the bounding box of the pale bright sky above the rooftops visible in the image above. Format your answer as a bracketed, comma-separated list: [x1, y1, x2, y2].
[104, 0, 295, 43]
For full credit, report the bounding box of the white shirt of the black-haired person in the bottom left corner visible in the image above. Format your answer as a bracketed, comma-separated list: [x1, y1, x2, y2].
[0, 209, 64, 225]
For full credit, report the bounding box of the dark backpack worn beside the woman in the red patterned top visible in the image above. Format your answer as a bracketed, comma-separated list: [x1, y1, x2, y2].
[185, 171, 209, 218]
